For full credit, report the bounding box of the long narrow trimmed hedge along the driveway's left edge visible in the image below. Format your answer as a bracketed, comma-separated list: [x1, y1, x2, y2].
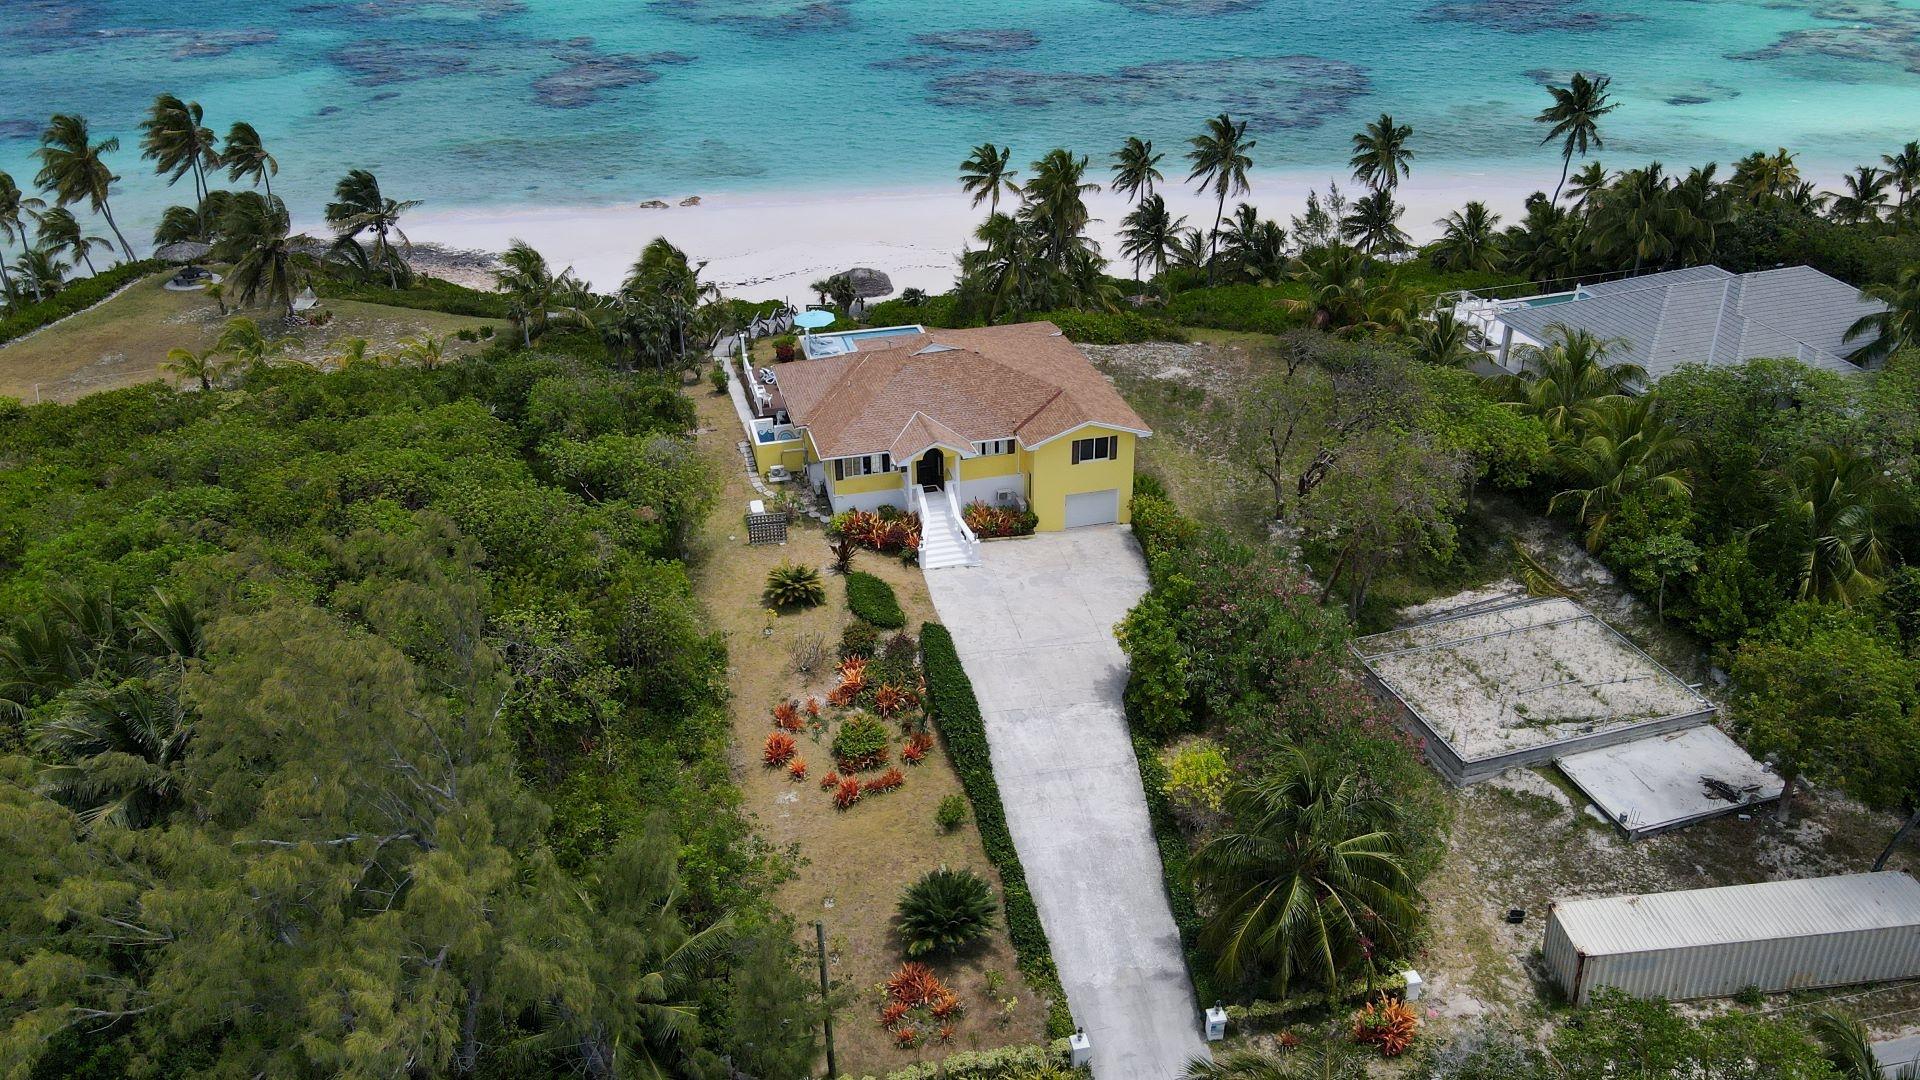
[920, 623, 1073, 1038]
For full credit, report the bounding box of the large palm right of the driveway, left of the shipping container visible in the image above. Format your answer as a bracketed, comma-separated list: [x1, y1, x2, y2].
[1192, 749, 1421, 995]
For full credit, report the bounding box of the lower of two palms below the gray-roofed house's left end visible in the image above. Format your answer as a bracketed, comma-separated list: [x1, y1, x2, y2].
[1548, 396, 1693, 552]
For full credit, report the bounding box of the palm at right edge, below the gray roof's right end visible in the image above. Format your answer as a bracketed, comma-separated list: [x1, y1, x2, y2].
[1776, 446, 1901, 603]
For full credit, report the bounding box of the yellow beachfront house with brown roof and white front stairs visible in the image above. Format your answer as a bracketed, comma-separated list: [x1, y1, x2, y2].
[753, 323, 1152, 530]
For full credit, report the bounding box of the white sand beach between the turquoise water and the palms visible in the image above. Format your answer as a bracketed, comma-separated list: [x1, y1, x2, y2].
[389, 163, 1559, 302]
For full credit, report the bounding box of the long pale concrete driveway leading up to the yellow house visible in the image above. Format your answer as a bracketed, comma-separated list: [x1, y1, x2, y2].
[927, 527, 1206, 1080]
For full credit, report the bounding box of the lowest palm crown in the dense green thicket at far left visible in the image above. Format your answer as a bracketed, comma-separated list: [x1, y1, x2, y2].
[33, 678, 192, 828]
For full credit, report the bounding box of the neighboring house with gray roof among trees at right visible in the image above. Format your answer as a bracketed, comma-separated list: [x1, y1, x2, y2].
[1455, 267, 1885, 380]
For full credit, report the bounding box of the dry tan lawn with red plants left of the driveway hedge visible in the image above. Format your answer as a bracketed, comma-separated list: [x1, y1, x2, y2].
[689, 384, 1046, 1076]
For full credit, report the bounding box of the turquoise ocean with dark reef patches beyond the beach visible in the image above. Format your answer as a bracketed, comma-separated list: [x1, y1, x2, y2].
[0, 0, 1920, 231]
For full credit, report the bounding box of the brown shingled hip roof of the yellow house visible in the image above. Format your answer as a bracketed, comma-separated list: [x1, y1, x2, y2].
[774, 323, 1146, 459]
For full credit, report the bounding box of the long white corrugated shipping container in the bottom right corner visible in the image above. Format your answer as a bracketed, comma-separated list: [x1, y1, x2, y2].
[1546, 871, 1920, 1005]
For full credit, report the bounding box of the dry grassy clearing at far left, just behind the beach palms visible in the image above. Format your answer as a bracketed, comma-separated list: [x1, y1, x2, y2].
[0, 273, 490, 404]
